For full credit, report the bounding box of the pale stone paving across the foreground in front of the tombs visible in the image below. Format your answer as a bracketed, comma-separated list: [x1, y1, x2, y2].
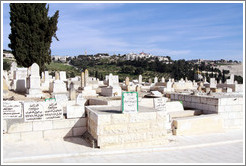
[3, 129, 245, 164]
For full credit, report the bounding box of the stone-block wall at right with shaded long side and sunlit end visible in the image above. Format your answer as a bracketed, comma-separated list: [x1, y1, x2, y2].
[171, 94, 244, 128]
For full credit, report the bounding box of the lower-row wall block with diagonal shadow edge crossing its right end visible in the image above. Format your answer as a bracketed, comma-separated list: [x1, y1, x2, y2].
[43, 128, 73, 140]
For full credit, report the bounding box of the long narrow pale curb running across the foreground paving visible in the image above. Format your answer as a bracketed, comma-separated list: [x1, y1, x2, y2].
[3, 139, 243, 163]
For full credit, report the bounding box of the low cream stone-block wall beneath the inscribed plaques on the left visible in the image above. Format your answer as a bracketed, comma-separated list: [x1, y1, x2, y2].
[3, 118, 87, 141]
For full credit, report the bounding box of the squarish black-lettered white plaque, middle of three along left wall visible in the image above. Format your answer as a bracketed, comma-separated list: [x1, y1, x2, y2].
[24, 102, 44, 122]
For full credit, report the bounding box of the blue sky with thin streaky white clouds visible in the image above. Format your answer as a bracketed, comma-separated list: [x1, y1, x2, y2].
[3, 3, 243, 61]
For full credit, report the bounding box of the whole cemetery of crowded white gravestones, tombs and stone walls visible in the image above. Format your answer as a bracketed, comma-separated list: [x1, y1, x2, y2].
[2, 62, 244, 149]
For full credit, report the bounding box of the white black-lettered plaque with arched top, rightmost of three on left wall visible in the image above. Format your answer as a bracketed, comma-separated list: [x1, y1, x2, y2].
[44, 101, 63, 120]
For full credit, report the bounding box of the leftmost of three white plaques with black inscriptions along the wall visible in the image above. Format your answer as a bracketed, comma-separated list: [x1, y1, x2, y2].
[2, 101, 23, 119]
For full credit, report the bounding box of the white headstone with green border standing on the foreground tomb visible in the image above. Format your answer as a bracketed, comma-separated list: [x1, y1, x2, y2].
[121, 92, 138, 113]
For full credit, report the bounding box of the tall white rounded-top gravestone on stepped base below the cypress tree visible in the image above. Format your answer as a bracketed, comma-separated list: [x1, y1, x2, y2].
[26, 63, 43, 98]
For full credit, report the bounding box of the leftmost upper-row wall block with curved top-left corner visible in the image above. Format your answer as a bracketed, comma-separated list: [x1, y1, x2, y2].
[8, 122, 32, 133]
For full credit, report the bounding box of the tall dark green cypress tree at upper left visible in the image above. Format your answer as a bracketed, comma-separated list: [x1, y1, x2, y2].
[9, 3, 59, 72]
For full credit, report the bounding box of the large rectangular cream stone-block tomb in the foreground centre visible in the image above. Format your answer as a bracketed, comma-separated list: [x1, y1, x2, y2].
[86, 106, 168, 148]
